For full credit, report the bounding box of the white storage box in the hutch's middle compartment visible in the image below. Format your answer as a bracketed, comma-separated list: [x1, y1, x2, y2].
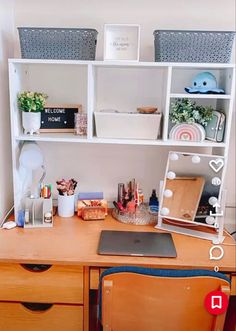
[94, 111, 161, 139]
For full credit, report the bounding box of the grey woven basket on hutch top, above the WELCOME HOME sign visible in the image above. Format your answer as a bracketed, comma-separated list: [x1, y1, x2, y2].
[18, 27, 98, 60]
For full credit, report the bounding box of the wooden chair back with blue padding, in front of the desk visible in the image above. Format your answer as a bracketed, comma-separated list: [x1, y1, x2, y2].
[100, 267, 230, 331]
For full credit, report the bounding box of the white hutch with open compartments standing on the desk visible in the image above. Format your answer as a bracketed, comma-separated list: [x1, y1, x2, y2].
[9, 59, 235, 243]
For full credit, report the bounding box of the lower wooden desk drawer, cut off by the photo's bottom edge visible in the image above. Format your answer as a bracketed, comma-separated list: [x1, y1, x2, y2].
[0, 302, 83, 331]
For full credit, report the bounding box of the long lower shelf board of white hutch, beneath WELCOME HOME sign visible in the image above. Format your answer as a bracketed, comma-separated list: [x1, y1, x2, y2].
[15, 134, 226, 148]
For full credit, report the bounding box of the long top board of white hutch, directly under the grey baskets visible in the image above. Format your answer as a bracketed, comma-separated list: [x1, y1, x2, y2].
[8, 58, 235, 69]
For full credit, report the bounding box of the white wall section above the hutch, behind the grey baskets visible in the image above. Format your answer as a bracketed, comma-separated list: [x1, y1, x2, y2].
[13, 0, 235, 60]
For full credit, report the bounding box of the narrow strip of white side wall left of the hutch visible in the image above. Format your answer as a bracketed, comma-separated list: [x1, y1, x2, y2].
[0, 0, 14, 221]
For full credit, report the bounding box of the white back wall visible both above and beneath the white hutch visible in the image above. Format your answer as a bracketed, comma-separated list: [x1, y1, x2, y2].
[2, 0, 235, 223]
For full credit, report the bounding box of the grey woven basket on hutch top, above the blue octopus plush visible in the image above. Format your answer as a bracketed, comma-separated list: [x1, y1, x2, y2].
[153, 30, 235, 63]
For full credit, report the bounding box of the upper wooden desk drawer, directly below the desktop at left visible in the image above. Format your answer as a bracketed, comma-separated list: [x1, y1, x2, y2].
[0, 264, 83, 304]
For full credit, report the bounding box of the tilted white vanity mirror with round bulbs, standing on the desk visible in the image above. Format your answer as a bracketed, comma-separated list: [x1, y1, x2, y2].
[157, 152, 224, 244]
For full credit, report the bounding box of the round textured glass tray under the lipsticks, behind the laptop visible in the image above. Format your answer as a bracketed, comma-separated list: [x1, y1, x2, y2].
[112, 205, 158, 225]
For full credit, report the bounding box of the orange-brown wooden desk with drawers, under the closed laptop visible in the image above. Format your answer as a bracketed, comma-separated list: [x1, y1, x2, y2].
[0, 216, 236, 331]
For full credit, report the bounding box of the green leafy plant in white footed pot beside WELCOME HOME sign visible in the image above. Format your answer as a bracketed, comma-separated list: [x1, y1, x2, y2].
[17, 91, 47, 135]
